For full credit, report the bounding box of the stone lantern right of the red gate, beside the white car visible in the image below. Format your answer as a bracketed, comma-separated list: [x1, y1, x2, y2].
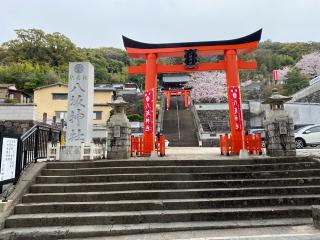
[263, 88, 296, 157]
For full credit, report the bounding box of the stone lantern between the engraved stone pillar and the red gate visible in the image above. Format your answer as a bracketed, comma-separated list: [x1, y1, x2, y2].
[107, 97, 131, 159]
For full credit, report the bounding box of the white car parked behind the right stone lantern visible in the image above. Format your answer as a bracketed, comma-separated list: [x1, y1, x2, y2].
[294, 125, 320, 149]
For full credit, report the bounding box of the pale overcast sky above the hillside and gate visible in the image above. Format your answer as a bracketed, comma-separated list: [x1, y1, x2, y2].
[0, 0, 320, 48]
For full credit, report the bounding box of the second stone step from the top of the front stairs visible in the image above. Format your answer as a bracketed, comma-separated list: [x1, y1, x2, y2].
[42, 162, 320, 176]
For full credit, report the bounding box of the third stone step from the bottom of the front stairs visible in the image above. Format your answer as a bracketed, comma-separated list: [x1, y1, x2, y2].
[15, 194, 320, 214]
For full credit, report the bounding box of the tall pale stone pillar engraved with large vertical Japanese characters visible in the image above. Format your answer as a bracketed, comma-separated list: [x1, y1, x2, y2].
[61, 62, 94, 161]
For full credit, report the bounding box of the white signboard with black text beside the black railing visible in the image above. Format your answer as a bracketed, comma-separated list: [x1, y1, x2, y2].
[0, 137, 18, 182]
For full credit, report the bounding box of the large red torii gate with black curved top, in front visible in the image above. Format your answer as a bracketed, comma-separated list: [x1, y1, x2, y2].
[122, 29, 262, 155]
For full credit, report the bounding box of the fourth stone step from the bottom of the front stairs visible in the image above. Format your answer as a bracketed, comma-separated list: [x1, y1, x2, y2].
[22, 186, 320, 203]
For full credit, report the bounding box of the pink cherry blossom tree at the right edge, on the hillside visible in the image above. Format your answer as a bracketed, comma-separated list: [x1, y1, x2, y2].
[296, 52, 320, 77]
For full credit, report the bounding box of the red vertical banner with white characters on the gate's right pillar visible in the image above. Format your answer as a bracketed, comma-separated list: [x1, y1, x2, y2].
[228, 87, 242, 131]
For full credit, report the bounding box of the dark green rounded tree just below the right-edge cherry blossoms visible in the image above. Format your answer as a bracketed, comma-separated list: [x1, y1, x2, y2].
[283, 68, 309, 95]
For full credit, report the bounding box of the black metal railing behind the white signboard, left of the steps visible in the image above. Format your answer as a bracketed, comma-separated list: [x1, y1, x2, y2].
[0, 125, 61, 192]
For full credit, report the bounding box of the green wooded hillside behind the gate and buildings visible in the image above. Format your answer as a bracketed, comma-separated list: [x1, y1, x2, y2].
[0, 29, 320, 98]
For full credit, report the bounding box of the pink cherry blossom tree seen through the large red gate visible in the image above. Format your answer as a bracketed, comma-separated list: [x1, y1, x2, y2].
[187, 72, 228, 103]
